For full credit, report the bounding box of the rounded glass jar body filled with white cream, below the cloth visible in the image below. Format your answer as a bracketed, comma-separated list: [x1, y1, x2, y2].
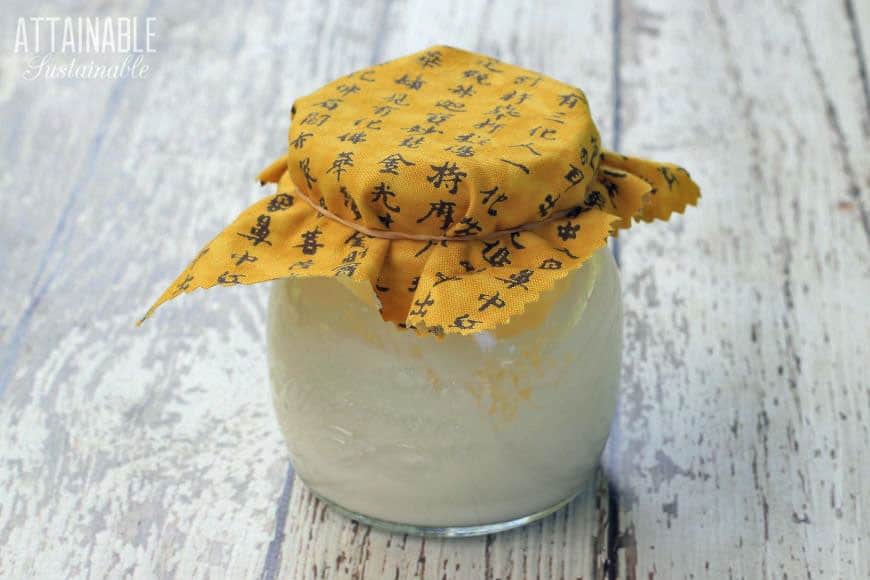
[268, 248, 622, 536]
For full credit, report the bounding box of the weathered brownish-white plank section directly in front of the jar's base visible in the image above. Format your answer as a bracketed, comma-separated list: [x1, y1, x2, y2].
[274, 482, 606, 580]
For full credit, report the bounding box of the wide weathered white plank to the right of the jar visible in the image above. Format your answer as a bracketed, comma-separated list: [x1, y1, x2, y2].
[609, 1, 870, 578]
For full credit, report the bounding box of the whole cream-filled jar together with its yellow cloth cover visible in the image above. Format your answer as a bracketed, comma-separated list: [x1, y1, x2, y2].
[146, 46, 700, 536]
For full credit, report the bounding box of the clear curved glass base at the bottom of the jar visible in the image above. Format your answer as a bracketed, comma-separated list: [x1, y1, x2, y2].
[303, 482, 586, 538]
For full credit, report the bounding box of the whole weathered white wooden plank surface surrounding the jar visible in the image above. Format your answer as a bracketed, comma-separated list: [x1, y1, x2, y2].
[0, 0, 870, 579]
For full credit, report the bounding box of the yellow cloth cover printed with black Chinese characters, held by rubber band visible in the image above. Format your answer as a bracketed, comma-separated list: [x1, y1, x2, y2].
[146, 46, 699, 334]
